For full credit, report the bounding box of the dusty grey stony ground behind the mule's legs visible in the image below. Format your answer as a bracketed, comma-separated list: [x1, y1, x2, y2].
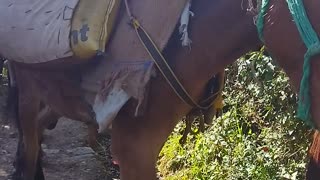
[0, 81, 119, 180]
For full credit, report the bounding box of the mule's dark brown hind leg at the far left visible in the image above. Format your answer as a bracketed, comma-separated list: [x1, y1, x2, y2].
[15, 65, 44, 180]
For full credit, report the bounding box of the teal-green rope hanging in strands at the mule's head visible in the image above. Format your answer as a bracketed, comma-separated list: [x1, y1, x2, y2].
[256, 0, 320, 127]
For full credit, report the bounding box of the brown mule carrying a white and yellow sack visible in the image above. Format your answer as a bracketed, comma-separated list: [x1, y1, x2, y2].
[8, 0, 320, 180]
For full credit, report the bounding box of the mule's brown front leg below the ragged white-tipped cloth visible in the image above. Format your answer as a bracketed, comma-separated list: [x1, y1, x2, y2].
[111, 107, 177, 180]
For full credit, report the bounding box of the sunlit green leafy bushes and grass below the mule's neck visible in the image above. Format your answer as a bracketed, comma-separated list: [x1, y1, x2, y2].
[158, 49, 311, 180]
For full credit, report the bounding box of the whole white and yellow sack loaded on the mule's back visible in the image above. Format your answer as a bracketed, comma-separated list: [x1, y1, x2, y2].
[0, 0, 121, 64]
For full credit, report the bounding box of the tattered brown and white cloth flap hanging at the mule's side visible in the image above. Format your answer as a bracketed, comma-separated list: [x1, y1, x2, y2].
[93, 61, 155, 132]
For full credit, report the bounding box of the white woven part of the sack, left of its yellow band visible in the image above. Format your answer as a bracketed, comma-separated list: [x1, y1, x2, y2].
[0, 0, 79, 63]
